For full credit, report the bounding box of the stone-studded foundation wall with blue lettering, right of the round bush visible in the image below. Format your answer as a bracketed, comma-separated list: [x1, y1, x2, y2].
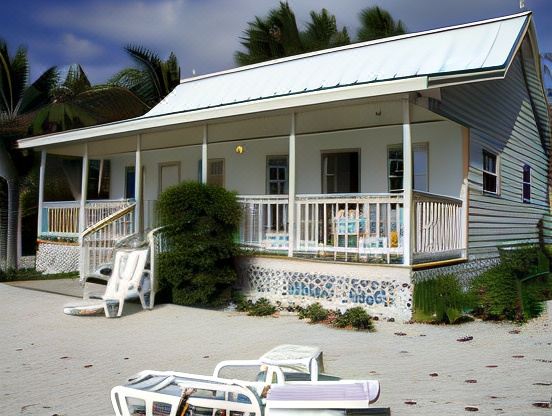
[238, 257, 412, 321]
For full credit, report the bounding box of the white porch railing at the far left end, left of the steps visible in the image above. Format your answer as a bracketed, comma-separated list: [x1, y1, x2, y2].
[40, 199, 133, 237]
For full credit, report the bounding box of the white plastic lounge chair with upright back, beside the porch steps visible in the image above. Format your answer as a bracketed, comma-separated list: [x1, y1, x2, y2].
[64, 235, 155, 318]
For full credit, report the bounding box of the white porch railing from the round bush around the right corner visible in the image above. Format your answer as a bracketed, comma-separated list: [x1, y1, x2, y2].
[238, 191, 465, 263]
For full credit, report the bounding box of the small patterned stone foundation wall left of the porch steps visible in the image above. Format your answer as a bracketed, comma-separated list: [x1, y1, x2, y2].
[36, 242, 80, 274]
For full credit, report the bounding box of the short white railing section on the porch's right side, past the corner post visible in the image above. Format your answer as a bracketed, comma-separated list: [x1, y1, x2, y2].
[412, 191, 465, 263]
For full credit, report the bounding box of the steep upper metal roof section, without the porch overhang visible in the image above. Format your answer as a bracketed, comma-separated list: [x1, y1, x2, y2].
[145, 13, 529, 117]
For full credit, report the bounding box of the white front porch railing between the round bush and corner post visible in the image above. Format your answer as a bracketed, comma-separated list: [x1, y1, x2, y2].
[238, 194, 403, 263]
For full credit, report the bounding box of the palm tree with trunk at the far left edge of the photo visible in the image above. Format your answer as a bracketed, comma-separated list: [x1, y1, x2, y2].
[0, 40, 56, 269]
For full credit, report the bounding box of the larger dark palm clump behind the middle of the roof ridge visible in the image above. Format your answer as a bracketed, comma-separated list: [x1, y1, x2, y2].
[234, 2, 350, 65]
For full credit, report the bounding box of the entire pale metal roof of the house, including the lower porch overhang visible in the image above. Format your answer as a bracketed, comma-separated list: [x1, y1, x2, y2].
[18, 12, 531, 148]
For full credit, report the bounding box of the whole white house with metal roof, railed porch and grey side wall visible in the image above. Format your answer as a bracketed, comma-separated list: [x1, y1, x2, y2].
[19, 13, 550, 319]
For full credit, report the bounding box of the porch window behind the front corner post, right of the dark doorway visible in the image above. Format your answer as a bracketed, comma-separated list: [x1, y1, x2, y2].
[387, 143, 429, 192]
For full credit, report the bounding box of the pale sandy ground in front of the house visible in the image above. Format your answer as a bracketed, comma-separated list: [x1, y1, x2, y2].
[0, 283, 552, 416]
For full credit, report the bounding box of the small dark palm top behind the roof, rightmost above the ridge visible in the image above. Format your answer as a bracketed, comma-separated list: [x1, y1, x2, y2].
[357, 6, 406, 42]
